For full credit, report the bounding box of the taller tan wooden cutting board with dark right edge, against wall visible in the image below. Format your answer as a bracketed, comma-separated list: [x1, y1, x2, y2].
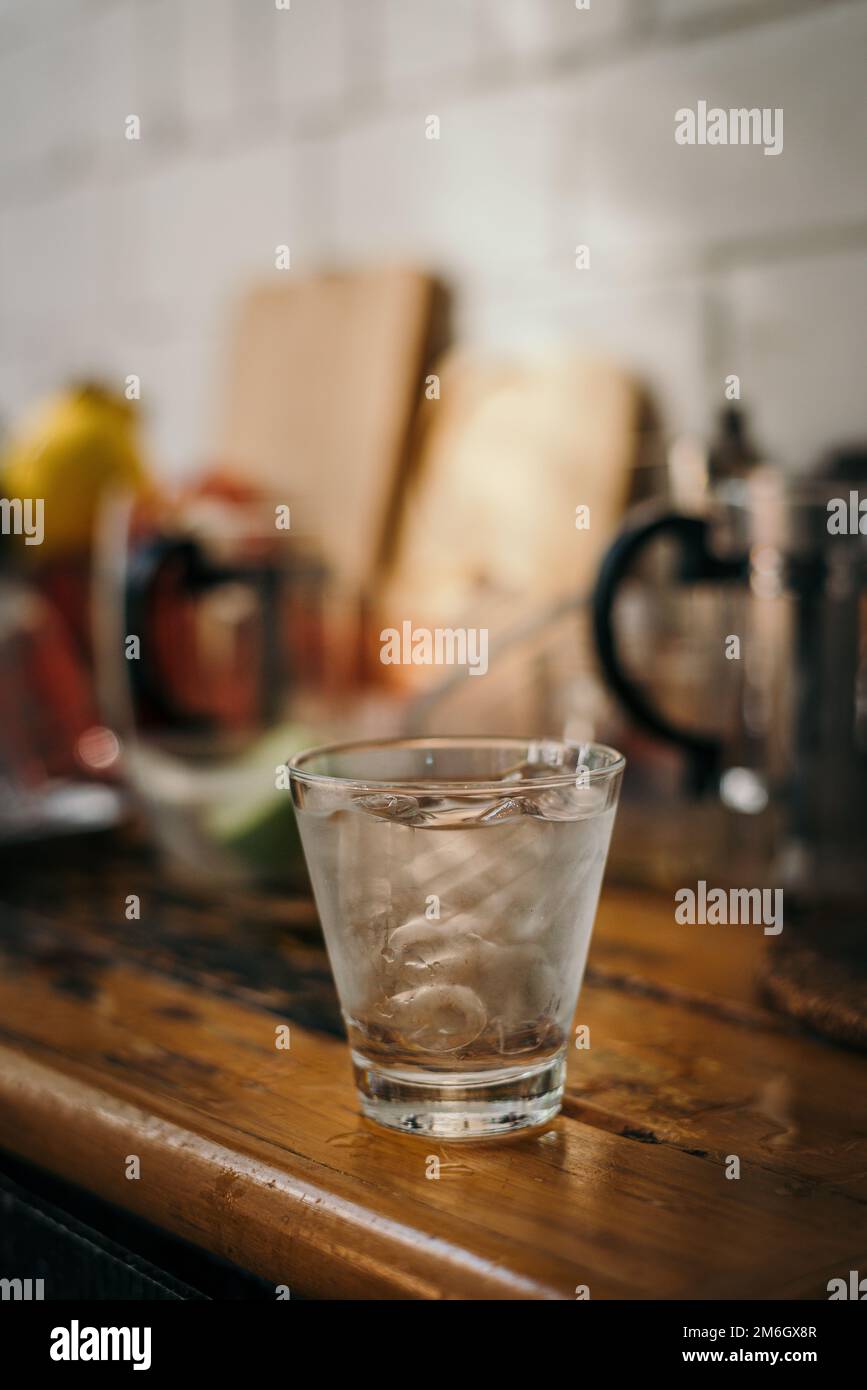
[217, 268, 435, 588]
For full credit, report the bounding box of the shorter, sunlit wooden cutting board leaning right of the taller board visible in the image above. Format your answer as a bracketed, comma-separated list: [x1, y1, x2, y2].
[382, 354, 642, 639]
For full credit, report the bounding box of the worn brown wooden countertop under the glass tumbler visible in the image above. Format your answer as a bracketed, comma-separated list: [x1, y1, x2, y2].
[0, 837, 867, 1298]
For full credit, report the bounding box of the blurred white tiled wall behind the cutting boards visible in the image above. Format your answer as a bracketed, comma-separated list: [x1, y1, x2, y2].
[0, 0, 867, 470]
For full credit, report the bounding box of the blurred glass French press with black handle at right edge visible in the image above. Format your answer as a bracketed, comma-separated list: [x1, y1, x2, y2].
[593, 466, 867, 912]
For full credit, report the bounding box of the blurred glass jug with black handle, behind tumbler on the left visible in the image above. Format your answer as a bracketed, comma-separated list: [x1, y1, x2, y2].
[94, 488, 340, 885]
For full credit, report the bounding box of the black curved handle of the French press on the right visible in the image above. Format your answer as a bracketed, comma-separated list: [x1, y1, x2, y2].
[593, 512, 746, 791]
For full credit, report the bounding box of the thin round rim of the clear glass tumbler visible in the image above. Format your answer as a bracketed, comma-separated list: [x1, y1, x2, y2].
[285, 734, 627, 795]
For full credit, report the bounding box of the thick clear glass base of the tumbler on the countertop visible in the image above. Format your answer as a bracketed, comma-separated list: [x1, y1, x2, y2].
[352, 1048, 565, 1140]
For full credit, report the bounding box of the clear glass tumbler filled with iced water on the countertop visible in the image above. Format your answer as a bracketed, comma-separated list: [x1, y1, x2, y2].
[289, 738, 624, 1138]
